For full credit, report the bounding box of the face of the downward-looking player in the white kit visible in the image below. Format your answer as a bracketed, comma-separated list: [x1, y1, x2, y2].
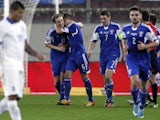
[11, 9, 24, 22]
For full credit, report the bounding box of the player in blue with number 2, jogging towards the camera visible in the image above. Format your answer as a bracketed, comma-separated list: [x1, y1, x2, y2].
[122, 6, 159, 118]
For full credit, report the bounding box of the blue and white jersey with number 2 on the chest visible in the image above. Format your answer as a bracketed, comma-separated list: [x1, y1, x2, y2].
[123, 23, 157, 62]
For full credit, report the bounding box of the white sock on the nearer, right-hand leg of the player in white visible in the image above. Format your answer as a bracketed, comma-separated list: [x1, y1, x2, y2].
[7, 100, 21, 120]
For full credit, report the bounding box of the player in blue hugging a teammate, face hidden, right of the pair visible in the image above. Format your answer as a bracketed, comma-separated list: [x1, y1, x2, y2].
[59, 14, 95, 106]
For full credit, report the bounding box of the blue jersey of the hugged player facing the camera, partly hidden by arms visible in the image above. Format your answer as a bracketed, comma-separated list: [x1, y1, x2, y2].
[45, 27, 67, 56]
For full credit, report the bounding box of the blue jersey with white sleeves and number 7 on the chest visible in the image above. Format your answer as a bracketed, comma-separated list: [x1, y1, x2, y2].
[91, 22, 121, 58]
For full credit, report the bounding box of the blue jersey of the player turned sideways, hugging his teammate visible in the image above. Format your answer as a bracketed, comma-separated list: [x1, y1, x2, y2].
[62, 23, 86, 55]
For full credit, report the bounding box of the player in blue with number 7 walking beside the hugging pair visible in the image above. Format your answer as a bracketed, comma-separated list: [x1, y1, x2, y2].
[88, 11, 120, 107]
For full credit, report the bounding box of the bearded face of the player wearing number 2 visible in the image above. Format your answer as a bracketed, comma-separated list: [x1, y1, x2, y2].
[129, 10, 141, 24]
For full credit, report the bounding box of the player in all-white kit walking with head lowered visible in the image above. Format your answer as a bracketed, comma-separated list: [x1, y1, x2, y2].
[0, 1, 44, 120]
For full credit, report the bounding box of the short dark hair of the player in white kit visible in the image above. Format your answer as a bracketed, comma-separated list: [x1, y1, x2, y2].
[10, 1, 25, 11]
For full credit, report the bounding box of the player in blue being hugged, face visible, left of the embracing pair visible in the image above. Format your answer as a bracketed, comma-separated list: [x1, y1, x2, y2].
[45, 14, 69, 105]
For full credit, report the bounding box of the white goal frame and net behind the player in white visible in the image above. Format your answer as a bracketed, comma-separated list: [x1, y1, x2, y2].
[1, 0, 39, 94]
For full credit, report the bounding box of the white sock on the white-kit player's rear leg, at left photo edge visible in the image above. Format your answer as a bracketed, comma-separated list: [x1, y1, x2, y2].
[0, 97, 8, 115]
